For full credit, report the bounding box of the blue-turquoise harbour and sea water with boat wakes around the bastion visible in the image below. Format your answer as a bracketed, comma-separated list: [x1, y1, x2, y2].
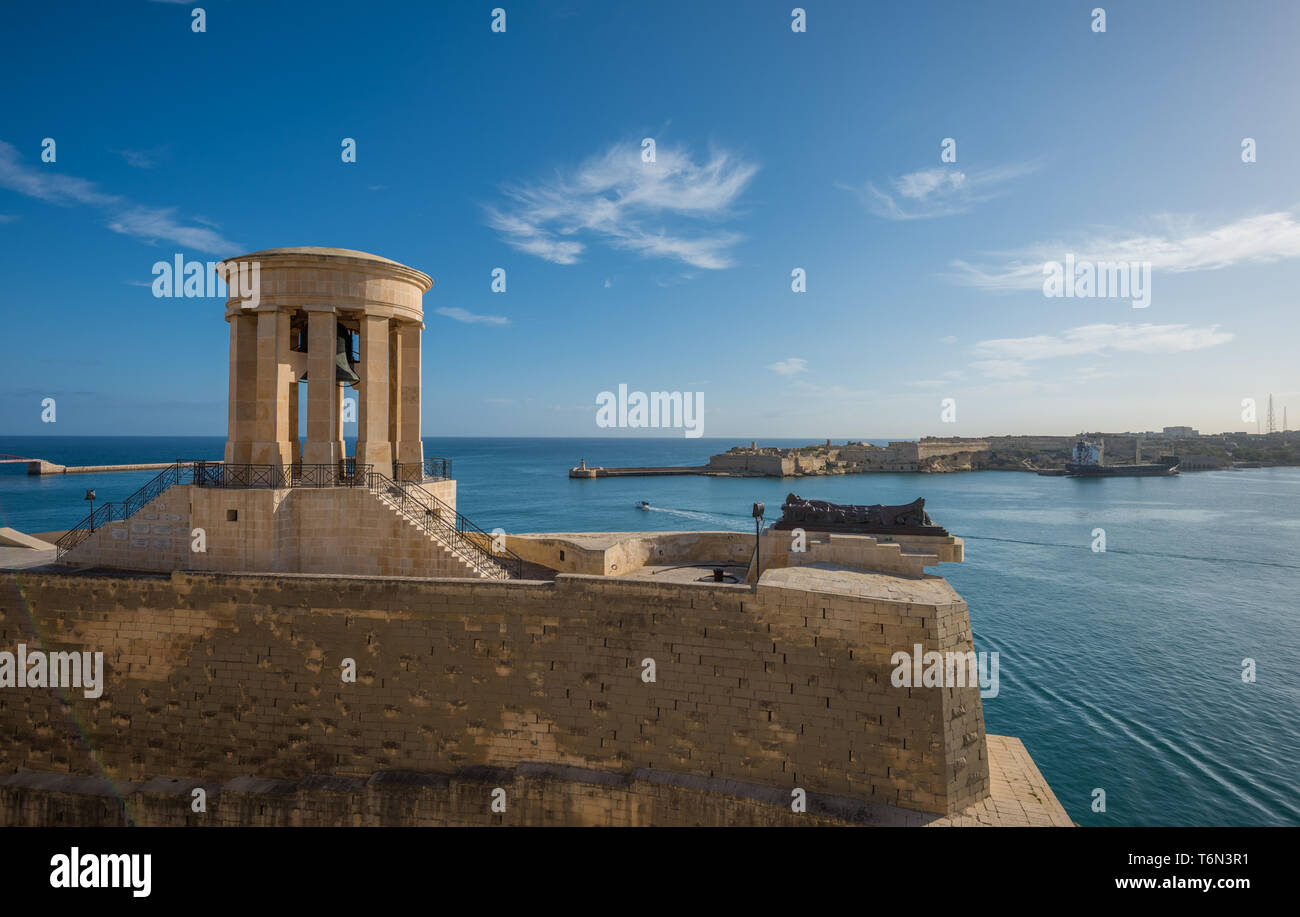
[0, 437, 1300, 825]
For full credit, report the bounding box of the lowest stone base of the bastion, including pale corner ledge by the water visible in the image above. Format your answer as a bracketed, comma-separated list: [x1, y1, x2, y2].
[0, 735, 1073, 827]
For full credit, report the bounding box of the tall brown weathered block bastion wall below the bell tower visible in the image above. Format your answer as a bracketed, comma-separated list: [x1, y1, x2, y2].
[0, 570, 988, 814]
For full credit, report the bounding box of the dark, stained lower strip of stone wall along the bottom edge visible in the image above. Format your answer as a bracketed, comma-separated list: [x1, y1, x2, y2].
[0, 764, 920, 827]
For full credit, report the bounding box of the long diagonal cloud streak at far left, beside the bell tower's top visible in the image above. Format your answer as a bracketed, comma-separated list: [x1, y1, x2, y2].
[0, 140, 243, 254]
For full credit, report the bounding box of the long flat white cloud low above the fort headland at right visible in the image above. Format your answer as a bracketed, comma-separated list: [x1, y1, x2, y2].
[971, 324, 1232, 361]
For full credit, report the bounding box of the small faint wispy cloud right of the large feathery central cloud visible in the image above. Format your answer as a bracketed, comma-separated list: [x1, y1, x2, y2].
[837, 163, 1039, 220]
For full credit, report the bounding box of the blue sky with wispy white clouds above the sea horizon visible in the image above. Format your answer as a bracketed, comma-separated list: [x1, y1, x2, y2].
[0, 0, 1300, 438]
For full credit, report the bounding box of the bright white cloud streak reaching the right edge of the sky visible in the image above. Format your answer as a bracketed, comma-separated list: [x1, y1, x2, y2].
[953, 211, 1300, 290]
